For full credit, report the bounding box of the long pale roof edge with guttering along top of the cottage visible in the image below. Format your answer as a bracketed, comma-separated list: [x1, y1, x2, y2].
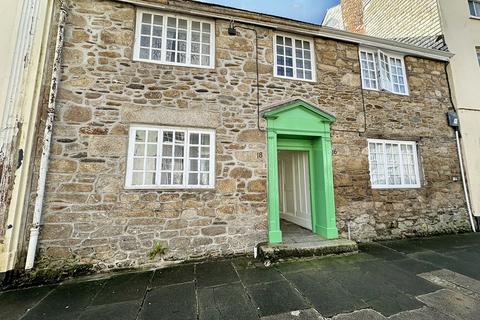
[115, 0, 454, 61]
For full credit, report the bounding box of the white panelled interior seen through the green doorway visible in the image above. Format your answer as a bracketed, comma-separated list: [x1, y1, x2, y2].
[278, 151, 312, 230]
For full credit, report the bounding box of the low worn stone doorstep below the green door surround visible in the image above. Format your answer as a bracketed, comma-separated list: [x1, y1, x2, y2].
[258, 239, 358, 262]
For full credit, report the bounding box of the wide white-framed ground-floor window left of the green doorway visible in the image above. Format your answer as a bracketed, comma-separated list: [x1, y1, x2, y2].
[125, 126, 215, 189]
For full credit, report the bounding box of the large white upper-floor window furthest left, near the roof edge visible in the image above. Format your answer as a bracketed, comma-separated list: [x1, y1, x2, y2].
[134, 9, 215, 68]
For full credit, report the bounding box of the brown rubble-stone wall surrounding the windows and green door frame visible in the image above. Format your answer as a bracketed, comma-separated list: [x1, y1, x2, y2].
[33, 0, 468, 269]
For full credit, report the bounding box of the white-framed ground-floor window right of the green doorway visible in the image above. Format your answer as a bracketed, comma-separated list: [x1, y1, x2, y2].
[368, 139, 420, 188]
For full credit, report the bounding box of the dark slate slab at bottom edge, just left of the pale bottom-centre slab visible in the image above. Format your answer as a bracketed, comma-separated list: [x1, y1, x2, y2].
[198, 283, 258, 320]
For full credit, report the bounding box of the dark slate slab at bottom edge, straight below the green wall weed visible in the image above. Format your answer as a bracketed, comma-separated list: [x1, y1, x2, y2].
[139, 282, 197, 320]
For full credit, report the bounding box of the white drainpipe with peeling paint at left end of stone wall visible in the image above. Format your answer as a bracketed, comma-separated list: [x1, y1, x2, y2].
[25, 2, 67, 270]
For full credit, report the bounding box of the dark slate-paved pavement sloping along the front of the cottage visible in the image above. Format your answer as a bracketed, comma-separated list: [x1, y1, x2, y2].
[0, 234, 480, 320]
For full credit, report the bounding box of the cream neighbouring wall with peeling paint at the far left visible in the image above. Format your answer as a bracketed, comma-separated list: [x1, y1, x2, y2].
[0, 0, 54, 273]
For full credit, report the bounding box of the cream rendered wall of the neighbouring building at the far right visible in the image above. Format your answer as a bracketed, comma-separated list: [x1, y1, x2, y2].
[438, 0, 480, 216]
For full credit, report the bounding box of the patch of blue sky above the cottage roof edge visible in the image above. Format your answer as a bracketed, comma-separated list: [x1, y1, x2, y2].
[197, 0, 339, 24]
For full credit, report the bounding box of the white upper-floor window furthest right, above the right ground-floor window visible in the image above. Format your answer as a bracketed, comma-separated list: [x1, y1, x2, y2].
[360, 49, 408, 95]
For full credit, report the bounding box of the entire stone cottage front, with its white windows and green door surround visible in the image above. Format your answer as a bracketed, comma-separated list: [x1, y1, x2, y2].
[30, 0, 468, 269]
